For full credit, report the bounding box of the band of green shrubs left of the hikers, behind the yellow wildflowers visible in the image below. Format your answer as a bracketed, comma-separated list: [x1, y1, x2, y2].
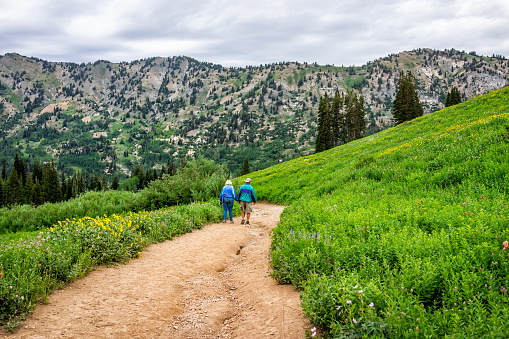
[0, 159, 228, 234]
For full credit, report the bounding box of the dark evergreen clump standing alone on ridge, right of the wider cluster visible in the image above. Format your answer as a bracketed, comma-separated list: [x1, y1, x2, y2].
[392, 71, 424, 125]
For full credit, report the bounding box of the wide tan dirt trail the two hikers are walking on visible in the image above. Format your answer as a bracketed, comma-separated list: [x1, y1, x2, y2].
[0, 203, 311, 339]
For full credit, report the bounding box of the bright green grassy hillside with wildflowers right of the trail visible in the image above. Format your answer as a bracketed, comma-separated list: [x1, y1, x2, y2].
[245, 88, 509, 338]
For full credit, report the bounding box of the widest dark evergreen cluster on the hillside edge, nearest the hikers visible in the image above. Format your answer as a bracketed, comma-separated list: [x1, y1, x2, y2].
[315, 90, 366, 153]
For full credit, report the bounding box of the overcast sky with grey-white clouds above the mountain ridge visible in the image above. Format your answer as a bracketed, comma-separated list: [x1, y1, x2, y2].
[0, 0, 509, 67]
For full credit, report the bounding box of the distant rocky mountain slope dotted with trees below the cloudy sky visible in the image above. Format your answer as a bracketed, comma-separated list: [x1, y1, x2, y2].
[0, 49, 509, 175]
